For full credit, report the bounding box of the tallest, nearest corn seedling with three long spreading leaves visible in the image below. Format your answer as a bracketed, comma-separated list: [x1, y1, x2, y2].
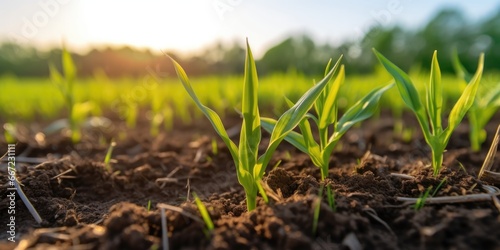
[170, 41, 342, 211]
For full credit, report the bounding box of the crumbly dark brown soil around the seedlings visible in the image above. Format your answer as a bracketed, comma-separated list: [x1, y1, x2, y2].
[0, 114, 500, 250]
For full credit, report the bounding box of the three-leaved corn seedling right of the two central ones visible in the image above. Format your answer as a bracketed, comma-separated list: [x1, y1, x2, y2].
[373, 49, 484, 176]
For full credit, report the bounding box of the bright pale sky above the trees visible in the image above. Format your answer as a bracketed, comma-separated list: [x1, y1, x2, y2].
[0, 0, 500, 56]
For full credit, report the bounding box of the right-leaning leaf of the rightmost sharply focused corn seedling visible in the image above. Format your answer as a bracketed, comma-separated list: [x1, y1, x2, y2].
[445, 54, 484, 138]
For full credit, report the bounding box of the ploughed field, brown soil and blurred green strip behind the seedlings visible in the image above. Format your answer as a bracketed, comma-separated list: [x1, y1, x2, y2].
[0, 53, 500, 250]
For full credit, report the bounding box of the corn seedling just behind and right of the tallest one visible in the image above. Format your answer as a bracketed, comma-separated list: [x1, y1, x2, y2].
[262, 63, 394, 180]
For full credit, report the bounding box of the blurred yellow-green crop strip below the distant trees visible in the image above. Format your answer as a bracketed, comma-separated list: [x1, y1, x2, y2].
[0, 53, 500, 122]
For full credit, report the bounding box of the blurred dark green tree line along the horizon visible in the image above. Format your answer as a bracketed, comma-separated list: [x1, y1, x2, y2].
[0, 9, 500, 77]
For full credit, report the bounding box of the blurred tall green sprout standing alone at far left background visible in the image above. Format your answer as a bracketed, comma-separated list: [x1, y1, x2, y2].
[49, 47, 81, 143]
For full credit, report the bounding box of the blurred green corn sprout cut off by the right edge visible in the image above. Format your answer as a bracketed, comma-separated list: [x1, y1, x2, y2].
[453, 51, 500, 152]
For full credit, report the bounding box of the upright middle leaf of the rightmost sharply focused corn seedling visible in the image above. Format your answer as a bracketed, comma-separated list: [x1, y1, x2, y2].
[426, 51, 443, 135]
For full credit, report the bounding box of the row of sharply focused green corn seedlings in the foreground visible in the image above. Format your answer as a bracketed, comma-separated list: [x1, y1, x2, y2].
[167, 40, 500, 211]
